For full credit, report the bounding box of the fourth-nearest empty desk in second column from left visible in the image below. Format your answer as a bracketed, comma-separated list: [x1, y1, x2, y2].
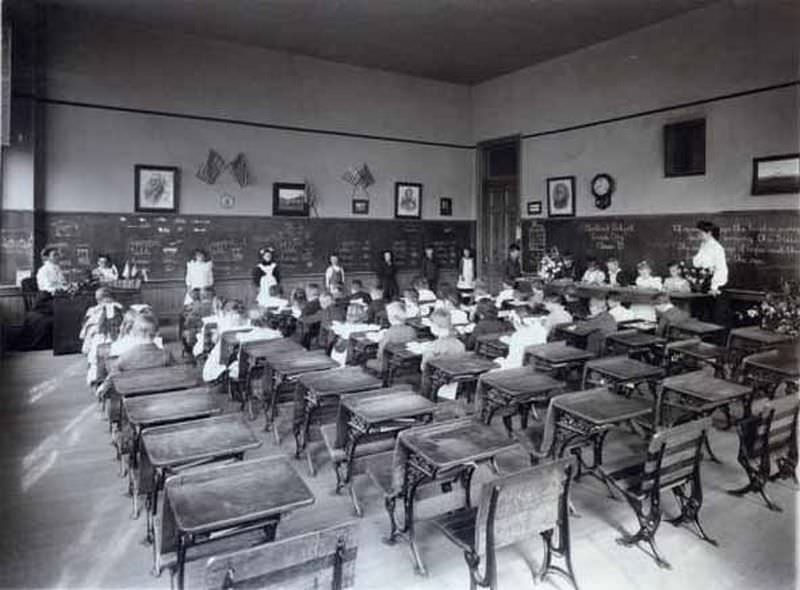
[264, 350, 339, 444]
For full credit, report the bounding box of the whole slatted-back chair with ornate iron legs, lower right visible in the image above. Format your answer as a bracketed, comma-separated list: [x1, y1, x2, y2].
[599, 418, 717, 569]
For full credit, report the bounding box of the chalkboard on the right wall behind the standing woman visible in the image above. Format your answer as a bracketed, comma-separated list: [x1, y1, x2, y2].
[523, 211, 800, 290]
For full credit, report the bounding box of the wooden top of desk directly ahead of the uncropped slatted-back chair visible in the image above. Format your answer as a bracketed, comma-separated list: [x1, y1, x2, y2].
[552, 387, 653, 426]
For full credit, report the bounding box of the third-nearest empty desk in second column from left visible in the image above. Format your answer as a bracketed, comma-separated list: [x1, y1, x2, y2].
[293, 367, 381, 474]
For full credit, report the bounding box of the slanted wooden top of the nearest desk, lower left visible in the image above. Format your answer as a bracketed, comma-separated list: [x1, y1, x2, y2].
[166, 457, 314, 534]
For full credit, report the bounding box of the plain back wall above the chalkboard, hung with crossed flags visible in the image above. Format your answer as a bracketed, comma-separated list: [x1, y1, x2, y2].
[36, 9, 474, 219]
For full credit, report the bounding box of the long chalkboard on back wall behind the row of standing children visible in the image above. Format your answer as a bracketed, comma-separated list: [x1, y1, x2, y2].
[44, 213, 474, 280]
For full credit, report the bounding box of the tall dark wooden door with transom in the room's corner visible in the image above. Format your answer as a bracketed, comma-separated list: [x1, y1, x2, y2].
[477, 136, 520, 292]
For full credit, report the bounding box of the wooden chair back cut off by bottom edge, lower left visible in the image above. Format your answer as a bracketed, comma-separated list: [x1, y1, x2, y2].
[205, 522, 358, 590]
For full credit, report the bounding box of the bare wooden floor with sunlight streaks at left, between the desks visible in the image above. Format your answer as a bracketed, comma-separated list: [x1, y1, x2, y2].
[0, 352, 796, 590]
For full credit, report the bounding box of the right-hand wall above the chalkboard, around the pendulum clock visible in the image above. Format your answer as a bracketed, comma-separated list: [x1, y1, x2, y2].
[473, 0, 800, 216]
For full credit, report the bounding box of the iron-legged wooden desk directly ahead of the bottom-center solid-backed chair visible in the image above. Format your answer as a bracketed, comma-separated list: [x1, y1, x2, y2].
[386, 419, 518, 574]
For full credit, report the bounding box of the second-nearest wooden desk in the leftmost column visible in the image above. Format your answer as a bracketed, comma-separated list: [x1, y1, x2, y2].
[140, 414, 262, 556]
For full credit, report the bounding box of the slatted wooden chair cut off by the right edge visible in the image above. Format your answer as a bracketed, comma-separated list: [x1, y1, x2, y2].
[728, 395, 800, 512]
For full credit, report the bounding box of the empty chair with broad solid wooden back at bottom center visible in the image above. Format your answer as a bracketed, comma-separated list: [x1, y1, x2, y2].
[433, 459, 578, 590]
